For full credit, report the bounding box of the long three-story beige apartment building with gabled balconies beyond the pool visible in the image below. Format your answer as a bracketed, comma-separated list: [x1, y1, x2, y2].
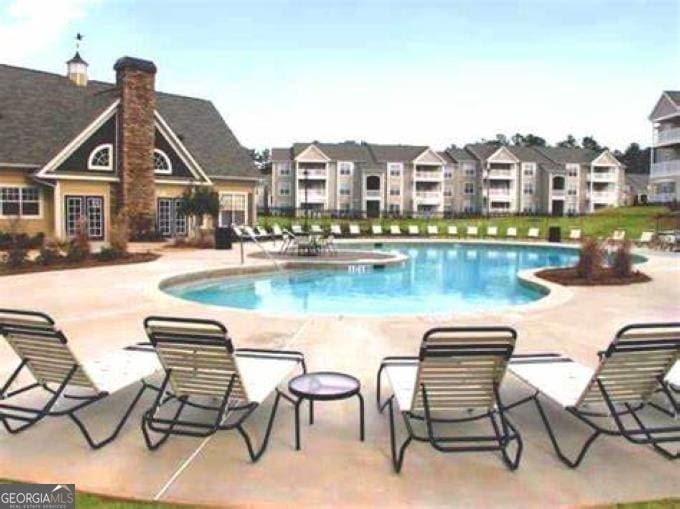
[272, 142, 623, 217]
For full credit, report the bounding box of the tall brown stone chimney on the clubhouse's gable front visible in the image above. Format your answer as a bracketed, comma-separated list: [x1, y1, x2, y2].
[113, 57, 156, 239]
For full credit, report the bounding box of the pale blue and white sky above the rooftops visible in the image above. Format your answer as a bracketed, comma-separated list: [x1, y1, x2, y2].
[0, 0, 680, 148]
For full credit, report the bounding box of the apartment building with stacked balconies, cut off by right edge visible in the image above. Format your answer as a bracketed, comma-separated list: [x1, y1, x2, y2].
[649, 90, 680, 202]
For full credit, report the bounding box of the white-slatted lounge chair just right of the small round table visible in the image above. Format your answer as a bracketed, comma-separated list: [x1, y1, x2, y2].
[377, 327, 522, 472]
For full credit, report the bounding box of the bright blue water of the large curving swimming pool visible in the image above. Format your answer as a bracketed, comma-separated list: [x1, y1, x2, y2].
[166, 243, 578, 315]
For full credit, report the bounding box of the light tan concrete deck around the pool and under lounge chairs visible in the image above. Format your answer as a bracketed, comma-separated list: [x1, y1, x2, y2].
[0, 239, 680, 507]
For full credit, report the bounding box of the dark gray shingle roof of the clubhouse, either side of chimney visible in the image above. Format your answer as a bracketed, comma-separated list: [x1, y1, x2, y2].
[0, 64, 258, 178]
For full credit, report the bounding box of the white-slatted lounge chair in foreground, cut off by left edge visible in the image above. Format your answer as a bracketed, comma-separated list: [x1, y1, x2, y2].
[0, 309, 161, 449]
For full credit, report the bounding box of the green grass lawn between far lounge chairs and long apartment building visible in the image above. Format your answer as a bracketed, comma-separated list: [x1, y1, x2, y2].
[258, 206, 669, 240]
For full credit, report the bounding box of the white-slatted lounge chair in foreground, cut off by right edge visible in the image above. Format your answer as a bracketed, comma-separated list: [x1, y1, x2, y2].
[508, 322, 680, 468]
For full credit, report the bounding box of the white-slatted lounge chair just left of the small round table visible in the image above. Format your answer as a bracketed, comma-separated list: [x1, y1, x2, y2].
[142, 316, 306, 456]
